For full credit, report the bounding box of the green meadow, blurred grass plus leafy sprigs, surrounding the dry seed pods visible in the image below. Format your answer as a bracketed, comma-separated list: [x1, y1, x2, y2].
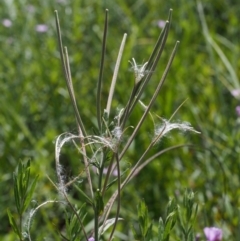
[0, 0, 240, 241]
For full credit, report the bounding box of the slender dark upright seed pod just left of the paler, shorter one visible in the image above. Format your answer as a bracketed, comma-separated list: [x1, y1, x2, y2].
[96, 9, 108, 130]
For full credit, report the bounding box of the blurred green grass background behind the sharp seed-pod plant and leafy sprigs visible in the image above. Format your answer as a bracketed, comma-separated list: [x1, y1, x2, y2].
[0, 0, 240, 240]
